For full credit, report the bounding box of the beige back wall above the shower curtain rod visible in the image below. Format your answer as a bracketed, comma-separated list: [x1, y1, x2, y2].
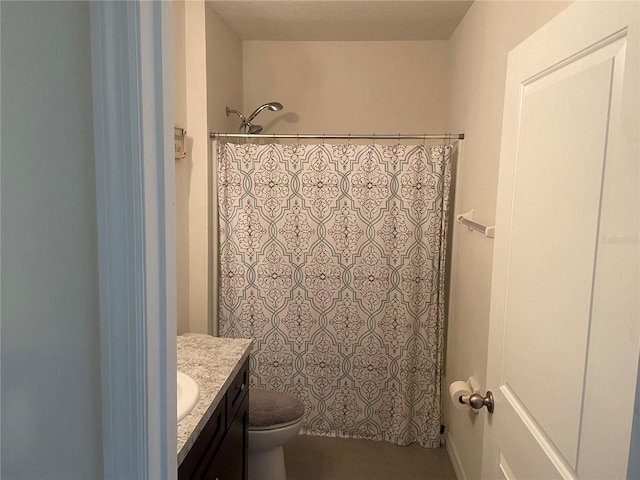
[244, 41, 449, 133]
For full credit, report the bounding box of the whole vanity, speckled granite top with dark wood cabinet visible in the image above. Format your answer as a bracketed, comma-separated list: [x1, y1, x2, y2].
[177, 336, 252, 480]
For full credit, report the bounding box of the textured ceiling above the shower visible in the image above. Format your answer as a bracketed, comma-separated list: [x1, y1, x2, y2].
[207, 0, 472, 41]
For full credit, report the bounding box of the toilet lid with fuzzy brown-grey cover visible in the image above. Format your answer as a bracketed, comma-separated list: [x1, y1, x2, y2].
[249, 388, 304, 430]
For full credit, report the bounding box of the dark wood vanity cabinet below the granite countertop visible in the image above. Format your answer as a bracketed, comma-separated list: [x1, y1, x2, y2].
[178, 360, 249, 480]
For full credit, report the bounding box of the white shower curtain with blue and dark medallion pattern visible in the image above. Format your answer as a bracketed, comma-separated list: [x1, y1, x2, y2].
[217, 143, 451, 448]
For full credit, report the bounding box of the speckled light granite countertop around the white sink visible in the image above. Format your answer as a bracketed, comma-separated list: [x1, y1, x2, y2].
[177, 336, 253, 465]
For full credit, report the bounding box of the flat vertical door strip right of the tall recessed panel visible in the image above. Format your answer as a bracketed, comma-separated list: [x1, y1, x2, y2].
[578, 34, 640, 478]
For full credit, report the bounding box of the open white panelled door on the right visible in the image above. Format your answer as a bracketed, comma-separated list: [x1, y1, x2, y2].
[483, 1, 640, 479]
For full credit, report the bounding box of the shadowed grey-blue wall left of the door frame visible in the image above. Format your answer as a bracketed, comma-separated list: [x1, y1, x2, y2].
[0, 2, 103, 479]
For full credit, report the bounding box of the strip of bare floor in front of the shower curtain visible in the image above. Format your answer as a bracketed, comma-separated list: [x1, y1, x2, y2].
[284, 435, 456, 480]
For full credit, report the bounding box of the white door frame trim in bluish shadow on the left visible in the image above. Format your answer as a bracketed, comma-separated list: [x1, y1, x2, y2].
[90, 1, 177, 479]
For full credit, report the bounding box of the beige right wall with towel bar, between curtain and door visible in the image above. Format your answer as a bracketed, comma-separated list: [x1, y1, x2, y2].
[443, 1, 570, 478]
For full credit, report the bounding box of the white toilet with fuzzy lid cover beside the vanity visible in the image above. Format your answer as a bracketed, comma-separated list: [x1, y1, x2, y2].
[249, 388, 304, 480]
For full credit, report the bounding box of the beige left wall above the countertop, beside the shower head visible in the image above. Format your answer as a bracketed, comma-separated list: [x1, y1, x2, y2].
[172, 0, 242, 334]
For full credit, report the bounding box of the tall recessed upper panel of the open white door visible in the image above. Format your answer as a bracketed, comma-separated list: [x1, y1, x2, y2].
[503, 47, 612, 468]
